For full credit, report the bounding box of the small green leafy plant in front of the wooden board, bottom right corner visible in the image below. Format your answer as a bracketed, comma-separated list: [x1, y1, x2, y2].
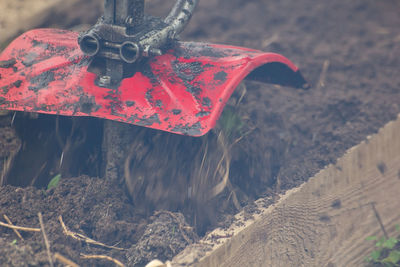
[366, 225, 400, 267]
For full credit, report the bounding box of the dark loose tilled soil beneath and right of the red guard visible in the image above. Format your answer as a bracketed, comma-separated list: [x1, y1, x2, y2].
[0, 0, 400, 266]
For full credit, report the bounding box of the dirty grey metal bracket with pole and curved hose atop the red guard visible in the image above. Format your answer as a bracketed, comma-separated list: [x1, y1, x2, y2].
[78, 0, 198, 87]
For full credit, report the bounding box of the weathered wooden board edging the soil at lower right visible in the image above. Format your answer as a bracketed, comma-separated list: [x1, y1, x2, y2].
[173, 114, 400, 267]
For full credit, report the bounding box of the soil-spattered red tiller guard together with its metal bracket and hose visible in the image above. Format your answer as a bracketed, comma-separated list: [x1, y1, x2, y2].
[0, 0, 305, 136]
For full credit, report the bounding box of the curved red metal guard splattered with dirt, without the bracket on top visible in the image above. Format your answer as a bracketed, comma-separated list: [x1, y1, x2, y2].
[0, 29, 304, 136]
